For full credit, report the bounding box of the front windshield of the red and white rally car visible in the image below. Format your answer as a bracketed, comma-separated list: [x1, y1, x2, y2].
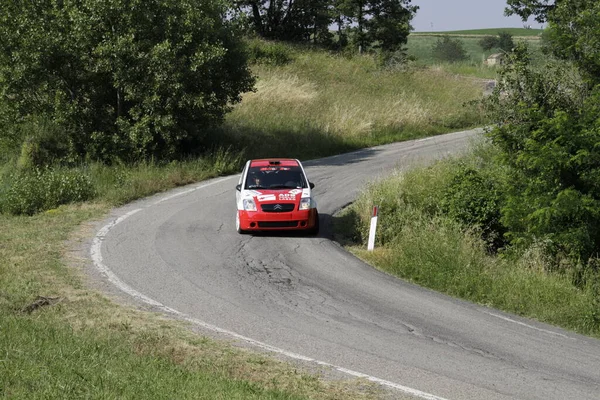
[245, 166, 308, 190]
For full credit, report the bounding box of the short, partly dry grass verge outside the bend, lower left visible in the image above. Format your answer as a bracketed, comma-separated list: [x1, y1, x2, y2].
[0, 203, 384, 399]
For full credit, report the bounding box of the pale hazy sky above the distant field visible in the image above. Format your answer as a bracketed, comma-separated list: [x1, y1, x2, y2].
[411, 0, 543, 32]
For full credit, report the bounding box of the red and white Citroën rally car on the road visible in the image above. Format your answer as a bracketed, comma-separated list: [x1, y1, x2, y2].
[235, 158, 319, 235]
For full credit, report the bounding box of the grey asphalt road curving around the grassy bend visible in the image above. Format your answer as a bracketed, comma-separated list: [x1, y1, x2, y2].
[90, 131, 600, 400]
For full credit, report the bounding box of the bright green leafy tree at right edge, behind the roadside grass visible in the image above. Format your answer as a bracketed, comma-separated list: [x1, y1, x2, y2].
[490, 45, 600, 260]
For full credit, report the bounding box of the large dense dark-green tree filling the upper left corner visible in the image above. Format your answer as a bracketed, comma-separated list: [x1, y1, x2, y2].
[0, 0, 253, 160]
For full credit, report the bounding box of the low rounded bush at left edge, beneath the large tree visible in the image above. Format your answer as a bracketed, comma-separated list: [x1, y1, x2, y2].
[0, 169, 96, 215]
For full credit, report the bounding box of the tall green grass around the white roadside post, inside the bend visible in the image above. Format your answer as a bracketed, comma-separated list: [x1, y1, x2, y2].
[334, 141, 600, 337]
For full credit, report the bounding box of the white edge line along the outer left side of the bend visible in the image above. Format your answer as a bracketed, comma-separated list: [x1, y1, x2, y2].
[90, 177, 447, 400]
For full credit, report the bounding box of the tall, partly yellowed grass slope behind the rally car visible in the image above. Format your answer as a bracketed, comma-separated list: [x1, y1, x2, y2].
[215, 45, 483, 159]
